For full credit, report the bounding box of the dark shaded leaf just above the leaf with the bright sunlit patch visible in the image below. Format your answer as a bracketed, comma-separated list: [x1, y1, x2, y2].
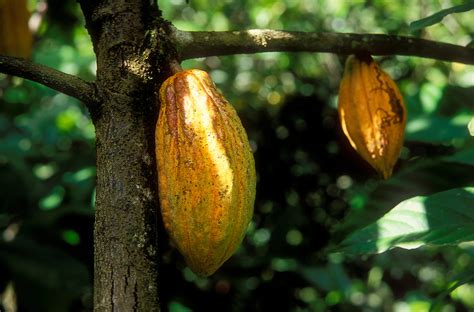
[332, 159, 474, 244]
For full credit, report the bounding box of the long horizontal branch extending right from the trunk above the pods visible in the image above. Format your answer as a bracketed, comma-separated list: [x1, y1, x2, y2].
[173, 28, 474, 64]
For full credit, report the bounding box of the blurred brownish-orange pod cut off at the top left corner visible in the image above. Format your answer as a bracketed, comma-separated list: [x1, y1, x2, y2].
[0, 0, 33, 58]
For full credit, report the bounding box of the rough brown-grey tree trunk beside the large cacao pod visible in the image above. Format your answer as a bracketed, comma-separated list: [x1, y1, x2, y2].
[80, 0, 167, 312]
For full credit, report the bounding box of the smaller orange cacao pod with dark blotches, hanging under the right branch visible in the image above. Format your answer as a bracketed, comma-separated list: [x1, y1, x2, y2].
[338, 55, 406, 179]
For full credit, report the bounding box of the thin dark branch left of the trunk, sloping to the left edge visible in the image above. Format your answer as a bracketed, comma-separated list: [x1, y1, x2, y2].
[0, 55, 98, 108]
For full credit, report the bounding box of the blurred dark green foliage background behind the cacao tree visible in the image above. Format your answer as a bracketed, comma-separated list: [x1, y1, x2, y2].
[0, 0, 474, 312]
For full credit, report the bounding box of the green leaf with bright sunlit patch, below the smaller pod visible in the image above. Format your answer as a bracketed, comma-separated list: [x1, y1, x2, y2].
[337, 187, 474, 254]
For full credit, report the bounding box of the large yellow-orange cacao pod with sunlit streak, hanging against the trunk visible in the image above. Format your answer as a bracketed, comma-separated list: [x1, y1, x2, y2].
[155, 69, 256, 276]
